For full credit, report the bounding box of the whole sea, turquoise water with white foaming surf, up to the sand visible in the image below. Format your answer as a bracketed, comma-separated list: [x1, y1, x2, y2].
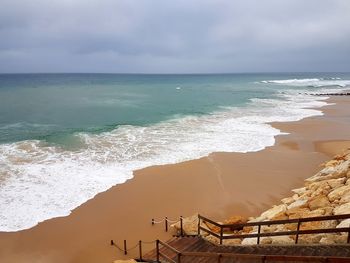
[0, 73, 350, 232]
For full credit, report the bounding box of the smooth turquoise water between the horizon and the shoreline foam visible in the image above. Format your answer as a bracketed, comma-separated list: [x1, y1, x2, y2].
[0, 73, 345, 144]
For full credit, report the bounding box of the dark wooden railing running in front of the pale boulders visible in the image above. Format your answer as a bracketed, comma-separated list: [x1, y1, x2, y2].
[198, 214, 350, 244]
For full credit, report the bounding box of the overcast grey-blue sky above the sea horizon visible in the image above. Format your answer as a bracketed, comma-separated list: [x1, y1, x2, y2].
[0, 0, 350, 73]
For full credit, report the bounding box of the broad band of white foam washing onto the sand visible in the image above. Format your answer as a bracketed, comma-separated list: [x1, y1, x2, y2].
[0, 93, 334, 231]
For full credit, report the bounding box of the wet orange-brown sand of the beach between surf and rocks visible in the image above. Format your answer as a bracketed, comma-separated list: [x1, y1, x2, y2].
[0, 97, 350, 262]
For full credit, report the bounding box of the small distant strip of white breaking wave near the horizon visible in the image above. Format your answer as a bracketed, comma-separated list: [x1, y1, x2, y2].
[261, 78, 350, 87]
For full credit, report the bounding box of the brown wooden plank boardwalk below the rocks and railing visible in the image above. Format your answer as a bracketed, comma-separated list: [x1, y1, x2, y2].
[143, 236, 350, 263]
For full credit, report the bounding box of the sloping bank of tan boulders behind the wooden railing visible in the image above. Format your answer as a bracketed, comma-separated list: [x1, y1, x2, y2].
[172, 149, 350, 245]
